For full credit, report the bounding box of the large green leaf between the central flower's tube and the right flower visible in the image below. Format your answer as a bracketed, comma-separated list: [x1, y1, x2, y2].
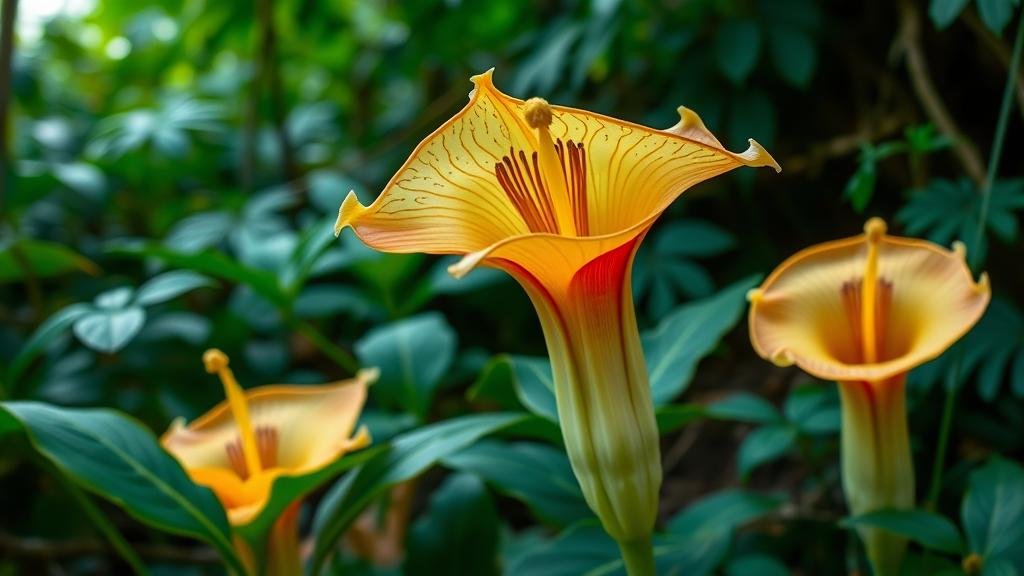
[641, 276, 760, 406]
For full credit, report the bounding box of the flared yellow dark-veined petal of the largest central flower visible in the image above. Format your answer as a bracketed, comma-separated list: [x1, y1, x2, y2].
[336, 71, 779, 282]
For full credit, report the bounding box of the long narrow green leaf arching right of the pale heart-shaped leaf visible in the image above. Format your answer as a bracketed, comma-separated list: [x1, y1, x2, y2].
[109, 244, 289, 307]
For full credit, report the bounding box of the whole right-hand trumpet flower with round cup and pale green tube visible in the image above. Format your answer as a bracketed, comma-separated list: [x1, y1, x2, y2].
[750, 218, 990, 576]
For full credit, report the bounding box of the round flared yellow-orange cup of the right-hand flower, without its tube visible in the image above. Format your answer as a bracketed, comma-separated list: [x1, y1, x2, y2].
[750, 219, 990, 382]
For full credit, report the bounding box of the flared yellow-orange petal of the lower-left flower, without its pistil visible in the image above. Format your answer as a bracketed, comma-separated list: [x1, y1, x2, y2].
[161, 364, 376, 525]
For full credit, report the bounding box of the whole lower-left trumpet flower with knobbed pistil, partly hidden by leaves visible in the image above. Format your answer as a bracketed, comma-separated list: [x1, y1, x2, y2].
[161, 349, 377, 574]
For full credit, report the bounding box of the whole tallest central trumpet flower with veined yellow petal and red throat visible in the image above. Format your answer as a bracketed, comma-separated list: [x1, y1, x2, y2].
[335, 71, 778, 574]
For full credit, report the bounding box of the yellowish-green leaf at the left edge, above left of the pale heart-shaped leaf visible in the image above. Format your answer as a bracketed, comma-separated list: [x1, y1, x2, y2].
[0, 238, 99, 283]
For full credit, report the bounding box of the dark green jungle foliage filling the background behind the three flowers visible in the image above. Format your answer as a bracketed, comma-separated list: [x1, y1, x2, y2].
[0, 0, 1024, 575]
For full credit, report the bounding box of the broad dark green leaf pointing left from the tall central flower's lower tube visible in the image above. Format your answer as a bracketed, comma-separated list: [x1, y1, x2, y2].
[441, 440, 594, 526]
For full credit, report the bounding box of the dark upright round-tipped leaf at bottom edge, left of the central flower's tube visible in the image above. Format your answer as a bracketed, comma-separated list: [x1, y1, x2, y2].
[403, 474, 499, 576]
